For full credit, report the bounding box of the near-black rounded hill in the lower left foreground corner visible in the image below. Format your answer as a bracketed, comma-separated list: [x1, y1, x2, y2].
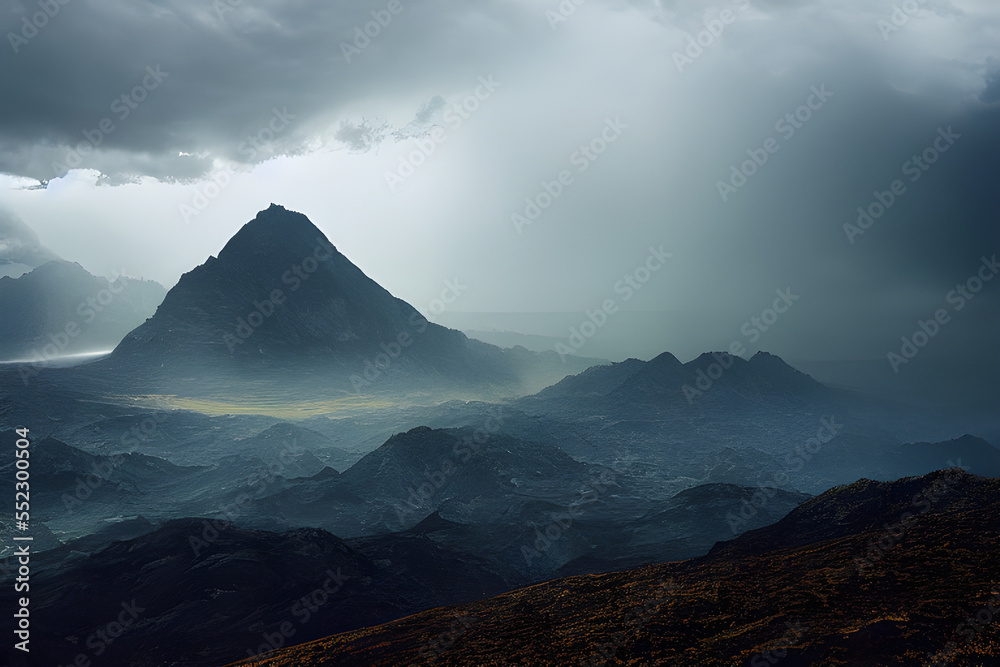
[0, 519, 398, 667]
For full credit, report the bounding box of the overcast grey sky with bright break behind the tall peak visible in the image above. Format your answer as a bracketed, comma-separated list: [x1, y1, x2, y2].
[0, 0, 1000, 394]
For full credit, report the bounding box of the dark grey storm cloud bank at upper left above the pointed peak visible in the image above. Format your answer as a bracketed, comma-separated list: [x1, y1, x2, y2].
[0, 0, 544, 181]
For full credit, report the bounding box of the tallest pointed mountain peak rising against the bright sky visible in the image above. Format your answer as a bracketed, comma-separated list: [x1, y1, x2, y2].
[93, 204, 586, 397]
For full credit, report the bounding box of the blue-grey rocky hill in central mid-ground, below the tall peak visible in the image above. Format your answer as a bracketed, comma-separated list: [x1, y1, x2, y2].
[256, 423, 605, 540]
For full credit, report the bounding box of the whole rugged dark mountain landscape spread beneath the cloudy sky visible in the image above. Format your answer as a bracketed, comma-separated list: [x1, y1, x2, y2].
[0, 205, 1000, 667]
